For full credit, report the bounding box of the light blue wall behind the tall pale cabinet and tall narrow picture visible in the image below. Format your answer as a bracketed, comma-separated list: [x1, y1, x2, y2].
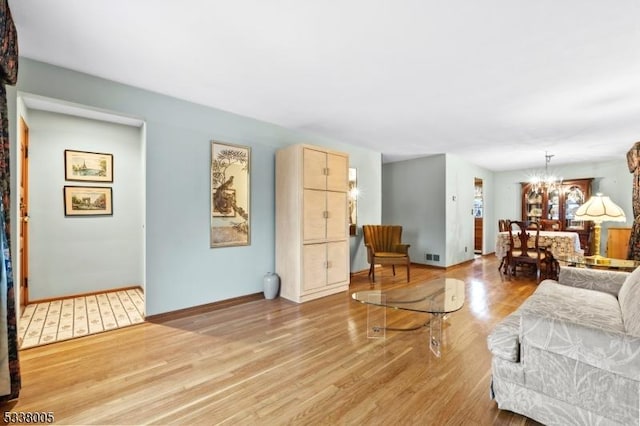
[8, 58, 381, 315]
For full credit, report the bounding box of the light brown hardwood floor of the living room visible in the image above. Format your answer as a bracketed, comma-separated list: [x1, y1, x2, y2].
[3, 255, 536, 425]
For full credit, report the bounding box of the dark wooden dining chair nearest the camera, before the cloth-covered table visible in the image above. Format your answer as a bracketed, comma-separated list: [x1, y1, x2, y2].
[504, 221, 548, 281]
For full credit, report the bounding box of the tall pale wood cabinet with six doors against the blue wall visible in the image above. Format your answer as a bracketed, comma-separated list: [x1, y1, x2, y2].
[276, 145, 349, 302]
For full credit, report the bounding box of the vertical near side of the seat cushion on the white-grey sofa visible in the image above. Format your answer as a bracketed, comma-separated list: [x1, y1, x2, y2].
[520, 312, 640, 380]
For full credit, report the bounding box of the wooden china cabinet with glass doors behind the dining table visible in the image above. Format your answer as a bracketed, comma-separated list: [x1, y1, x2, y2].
[522, 178, 593, 255]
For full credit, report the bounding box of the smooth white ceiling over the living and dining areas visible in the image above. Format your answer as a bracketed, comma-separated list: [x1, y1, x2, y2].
[10, 0, 640, 171]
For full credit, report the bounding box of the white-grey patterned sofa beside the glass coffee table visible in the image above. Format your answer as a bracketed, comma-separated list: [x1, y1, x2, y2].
[487, 267, 640, 426]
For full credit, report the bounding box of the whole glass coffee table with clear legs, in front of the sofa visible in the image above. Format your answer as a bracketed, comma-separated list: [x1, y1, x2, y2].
[351, 278, 465, 357]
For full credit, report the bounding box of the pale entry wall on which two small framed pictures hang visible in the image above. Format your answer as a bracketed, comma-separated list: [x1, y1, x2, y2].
[27, 110, 144, 300]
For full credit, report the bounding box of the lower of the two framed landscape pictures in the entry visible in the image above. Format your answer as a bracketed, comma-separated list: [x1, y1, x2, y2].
[63, 186, 113, 216]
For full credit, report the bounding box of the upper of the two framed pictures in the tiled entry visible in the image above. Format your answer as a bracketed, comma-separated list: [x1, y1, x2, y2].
[64, 149, 113, 182]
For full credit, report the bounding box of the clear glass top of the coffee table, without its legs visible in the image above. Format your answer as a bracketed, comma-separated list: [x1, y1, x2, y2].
[351, 278, 464, 314]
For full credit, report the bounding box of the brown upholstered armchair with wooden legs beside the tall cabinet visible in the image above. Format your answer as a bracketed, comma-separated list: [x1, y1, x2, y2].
[362, 225, 411, 282]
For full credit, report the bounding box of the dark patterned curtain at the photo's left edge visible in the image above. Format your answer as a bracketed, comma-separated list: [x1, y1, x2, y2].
[0, 0, 20, 401]
